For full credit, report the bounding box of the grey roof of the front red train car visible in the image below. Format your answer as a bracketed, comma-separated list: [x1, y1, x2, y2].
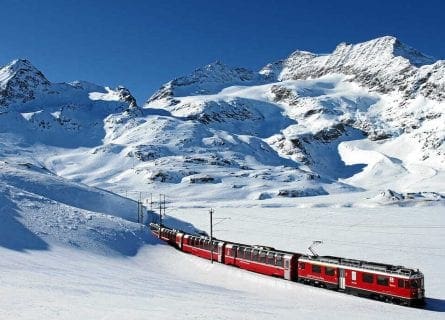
[301, 255, 421, 276]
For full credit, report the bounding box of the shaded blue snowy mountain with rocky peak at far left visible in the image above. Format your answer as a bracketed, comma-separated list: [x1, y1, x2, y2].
[0, 60, 140, 146]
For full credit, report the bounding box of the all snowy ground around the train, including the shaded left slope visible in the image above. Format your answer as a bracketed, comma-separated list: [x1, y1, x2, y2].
[0, 156, 445, 319]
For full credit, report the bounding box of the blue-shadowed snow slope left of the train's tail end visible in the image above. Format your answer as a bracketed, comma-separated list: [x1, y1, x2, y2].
[0, 161, 152, 255]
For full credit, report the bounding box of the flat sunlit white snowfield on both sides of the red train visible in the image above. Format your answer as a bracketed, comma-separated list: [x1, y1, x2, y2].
[0, 194, 445, 319]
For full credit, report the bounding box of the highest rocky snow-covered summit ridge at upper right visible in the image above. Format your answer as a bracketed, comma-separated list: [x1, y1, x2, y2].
[260, 37, 445, 101]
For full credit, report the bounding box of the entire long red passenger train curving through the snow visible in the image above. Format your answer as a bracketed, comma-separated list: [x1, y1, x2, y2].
[150, 223, 425, 306]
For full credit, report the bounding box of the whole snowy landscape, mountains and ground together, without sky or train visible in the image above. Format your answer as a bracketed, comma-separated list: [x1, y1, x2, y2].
[0, 37, 445, 319]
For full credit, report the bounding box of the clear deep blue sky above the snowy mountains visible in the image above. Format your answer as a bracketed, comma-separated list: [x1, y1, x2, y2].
[0, 0, 445, 104]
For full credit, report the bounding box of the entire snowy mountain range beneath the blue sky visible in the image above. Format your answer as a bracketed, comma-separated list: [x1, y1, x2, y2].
[0, 37, 445, 200]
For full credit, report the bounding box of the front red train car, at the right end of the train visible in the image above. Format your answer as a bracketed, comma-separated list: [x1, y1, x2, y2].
[298, 256, 425, 305]
